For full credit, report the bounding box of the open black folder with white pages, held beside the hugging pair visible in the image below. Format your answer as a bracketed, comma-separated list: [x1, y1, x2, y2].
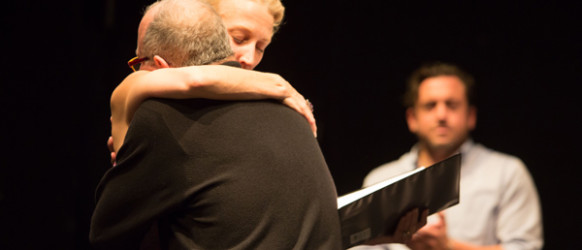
[338, 154, 461, 248]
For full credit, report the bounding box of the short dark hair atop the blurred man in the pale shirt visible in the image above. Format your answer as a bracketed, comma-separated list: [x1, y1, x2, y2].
[404, 62, 475, 108]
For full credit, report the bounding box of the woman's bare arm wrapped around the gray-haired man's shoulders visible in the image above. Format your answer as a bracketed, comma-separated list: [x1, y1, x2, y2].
[111, 65, 317, 152]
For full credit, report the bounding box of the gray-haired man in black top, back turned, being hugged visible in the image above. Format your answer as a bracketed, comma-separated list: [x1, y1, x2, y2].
[90, 0, 341, 249]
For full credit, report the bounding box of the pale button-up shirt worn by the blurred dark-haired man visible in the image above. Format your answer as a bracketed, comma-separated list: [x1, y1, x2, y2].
[364, 140, 543, 250]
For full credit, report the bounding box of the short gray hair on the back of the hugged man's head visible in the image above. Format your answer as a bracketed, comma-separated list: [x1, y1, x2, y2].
[138, 0, 233, 67]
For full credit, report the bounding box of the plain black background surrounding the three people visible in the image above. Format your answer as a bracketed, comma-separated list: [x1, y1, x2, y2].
[0, 0, 582, 249]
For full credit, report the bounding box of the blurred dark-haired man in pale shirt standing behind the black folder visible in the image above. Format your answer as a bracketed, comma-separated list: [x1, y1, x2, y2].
[364, 63, 543, 249]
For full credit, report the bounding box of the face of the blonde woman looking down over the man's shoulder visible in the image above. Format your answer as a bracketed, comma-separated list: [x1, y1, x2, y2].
[219, 0, 274, 69]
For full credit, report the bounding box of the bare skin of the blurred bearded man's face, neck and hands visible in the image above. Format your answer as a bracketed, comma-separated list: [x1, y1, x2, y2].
[406, 75, 502, 250]
